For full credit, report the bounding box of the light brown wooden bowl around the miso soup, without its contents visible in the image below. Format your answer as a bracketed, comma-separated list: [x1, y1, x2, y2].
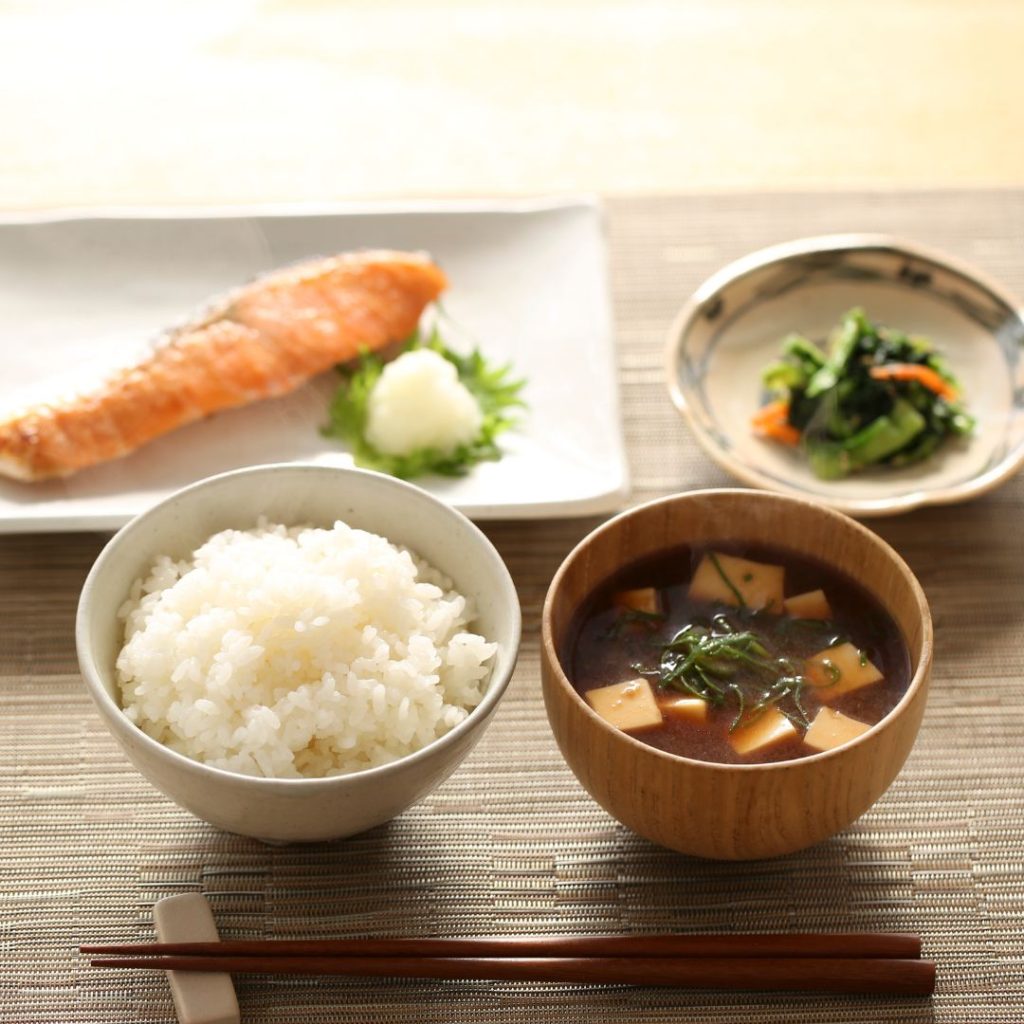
[541, 489, 932, 860]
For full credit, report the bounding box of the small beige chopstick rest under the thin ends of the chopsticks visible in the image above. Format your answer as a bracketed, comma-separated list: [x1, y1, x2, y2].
[153, 893, 241, 1024]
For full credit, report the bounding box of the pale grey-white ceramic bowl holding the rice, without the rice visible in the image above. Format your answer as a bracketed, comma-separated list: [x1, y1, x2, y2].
[76, 464, 520, 842]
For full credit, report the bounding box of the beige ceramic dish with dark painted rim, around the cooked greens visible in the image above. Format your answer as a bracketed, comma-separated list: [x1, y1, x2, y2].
[666, 234, 1024, 516]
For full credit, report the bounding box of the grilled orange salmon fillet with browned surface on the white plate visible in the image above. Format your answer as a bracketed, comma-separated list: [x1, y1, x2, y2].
[0, 252, 445, 480]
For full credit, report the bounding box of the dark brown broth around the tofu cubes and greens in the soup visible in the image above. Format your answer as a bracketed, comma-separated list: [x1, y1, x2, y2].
[560, 544, 910, 764]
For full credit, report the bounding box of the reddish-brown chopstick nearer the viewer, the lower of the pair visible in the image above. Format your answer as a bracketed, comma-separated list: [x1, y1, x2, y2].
[91, 955, 935, 995]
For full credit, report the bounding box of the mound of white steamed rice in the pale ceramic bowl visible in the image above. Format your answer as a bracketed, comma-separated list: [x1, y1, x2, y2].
[117, 520, 497, 778]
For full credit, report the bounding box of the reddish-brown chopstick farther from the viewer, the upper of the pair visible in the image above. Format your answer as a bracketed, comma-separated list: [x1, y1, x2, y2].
[79, 933, 921, 959]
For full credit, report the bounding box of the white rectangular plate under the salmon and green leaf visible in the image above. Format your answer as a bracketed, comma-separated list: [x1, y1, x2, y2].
[0, 200, 628, 532]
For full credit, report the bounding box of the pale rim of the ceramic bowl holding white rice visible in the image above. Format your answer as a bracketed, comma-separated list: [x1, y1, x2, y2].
[75, 463, 522, 790]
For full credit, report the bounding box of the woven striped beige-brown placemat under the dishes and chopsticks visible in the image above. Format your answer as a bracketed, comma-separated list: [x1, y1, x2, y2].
[0, 191, 1024, 1024]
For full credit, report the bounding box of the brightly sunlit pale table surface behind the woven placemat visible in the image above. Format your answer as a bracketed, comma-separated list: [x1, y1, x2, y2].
[0, 0, 1024, 208]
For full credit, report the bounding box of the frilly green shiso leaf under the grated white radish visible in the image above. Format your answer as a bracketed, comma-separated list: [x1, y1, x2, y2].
[322, 315, 526, 480]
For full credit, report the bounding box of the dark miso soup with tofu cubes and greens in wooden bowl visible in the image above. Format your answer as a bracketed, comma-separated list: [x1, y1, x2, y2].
[560, 544, 910, 764]
